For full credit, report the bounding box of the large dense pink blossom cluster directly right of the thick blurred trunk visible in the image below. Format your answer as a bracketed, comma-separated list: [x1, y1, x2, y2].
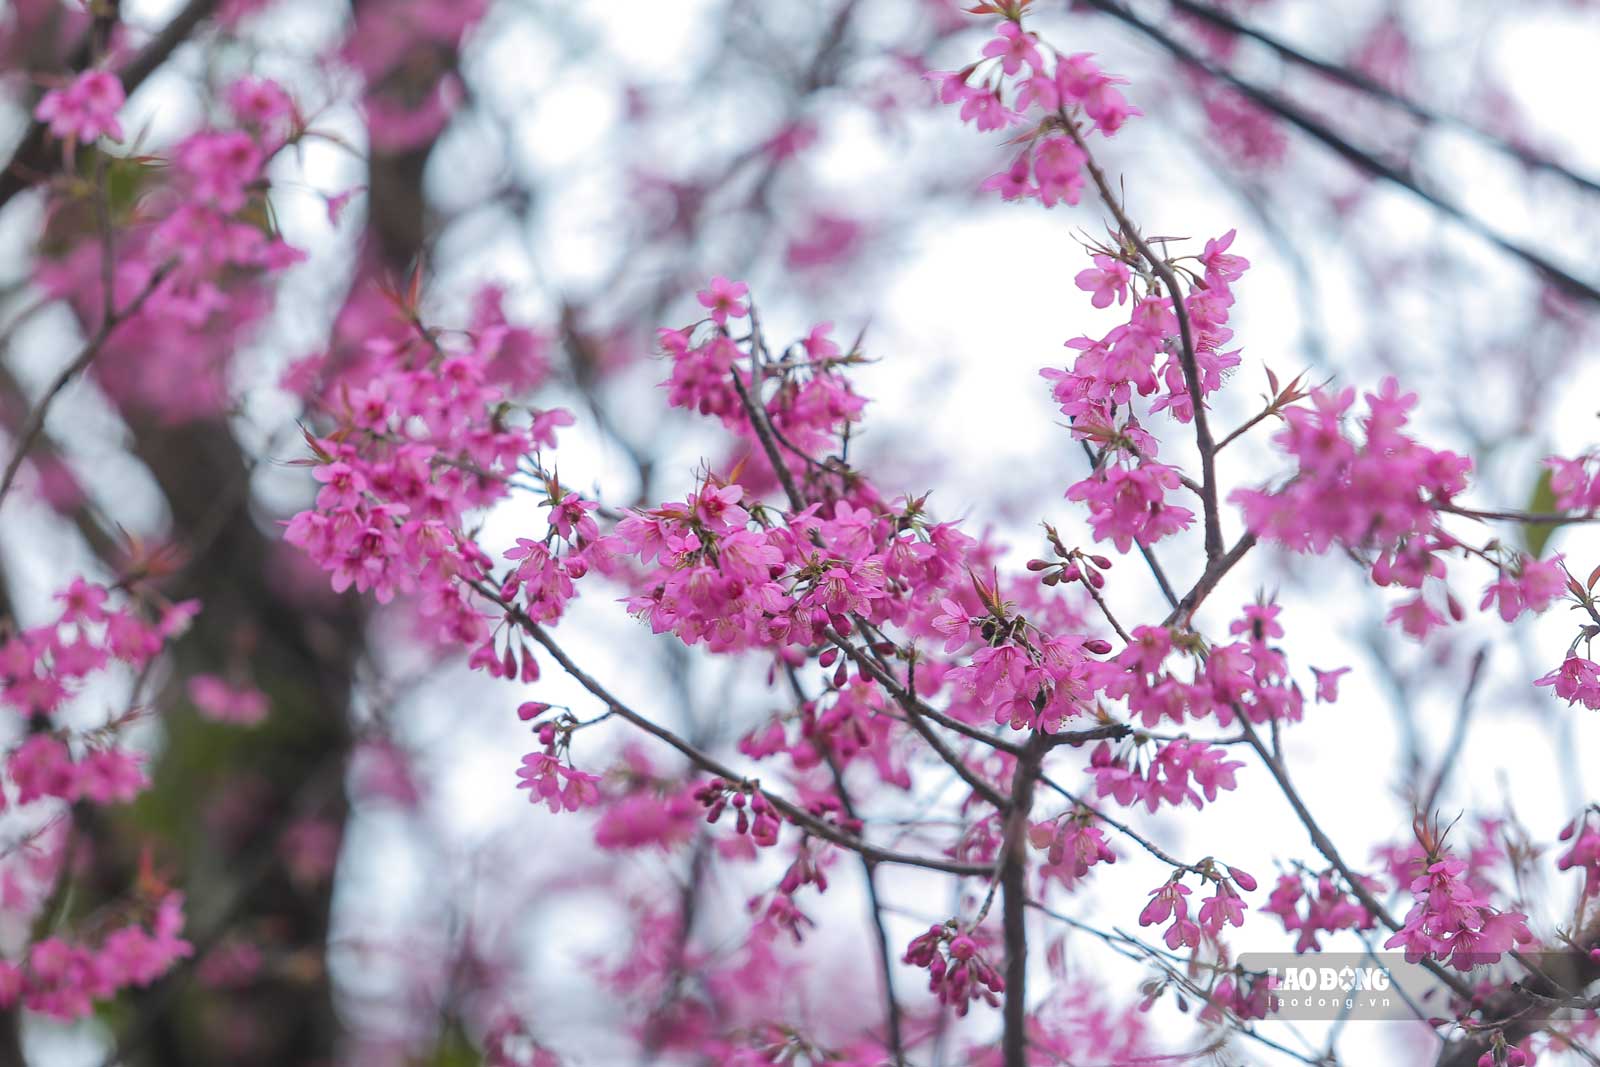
[285, 287, 566, 652]
